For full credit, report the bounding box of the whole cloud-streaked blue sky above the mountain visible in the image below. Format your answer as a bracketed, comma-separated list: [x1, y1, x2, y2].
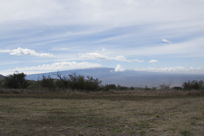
[0, 0, 204, 75]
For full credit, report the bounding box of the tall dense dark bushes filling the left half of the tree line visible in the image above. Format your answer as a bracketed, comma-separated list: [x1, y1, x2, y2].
[0, 73, 102, 91]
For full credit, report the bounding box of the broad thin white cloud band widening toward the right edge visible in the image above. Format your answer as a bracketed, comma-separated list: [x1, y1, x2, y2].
[115, 37, 204, 56]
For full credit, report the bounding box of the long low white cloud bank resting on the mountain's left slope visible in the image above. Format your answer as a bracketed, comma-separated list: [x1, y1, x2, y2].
[1, 61, 101, 75]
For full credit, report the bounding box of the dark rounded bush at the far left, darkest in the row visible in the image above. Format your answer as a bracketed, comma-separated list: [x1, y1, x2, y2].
[3, 73, 29, 89]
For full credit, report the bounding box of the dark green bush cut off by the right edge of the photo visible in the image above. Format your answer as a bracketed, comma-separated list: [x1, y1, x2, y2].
[183, 80, 204, 90]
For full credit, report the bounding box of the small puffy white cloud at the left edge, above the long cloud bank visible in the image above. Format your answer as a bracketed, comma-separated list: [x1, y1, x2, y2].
[0, 48, 54, 57]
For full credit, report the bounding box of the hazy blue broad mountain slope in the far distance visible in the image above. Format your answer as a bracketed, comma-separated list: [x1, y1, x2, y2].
[27, 68, 204, 87]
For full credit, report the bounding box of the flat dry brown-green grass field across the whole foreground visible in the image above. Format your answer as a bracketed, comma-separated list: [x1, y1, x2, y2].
[0, 91, 204, 136]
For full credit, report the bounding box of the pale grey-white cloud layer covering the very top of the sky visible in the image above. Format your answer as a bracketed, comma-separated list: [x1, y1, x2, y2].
[0, 0, 204, 25]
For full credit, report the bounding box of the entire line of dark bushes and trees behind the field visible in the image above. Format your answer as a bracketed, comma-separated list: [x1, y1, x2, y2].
[0, 73, 204, 91]
